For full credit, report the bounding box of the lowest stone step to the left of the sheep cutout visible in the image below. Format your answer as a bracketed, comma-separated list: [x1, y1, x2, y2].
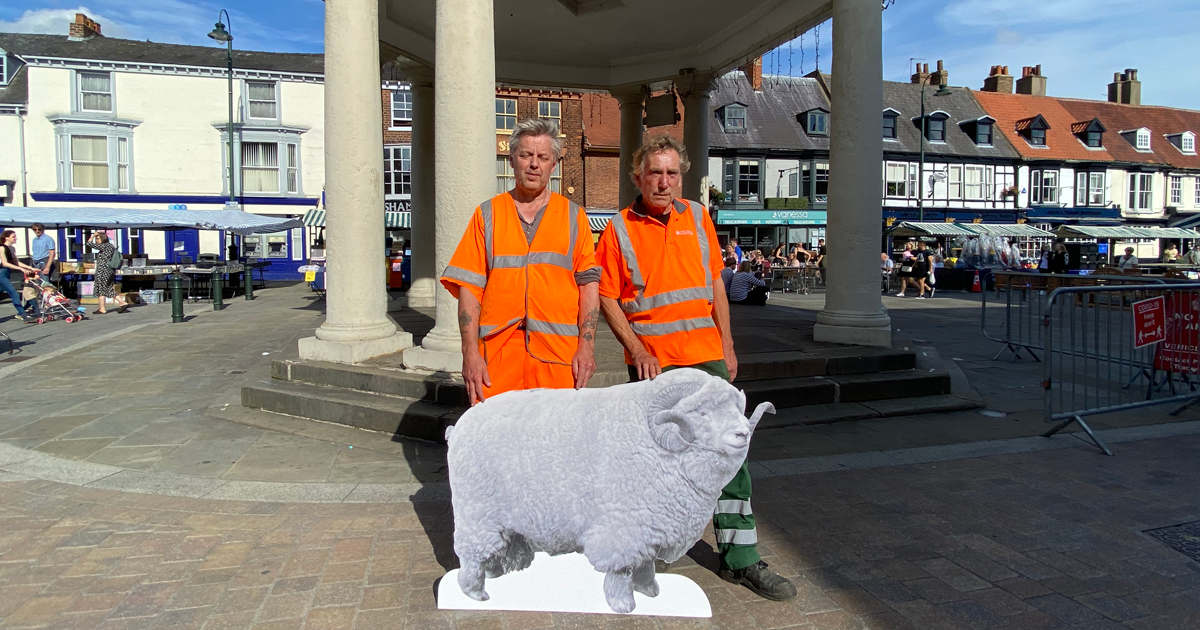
[241, 379, 463, 442]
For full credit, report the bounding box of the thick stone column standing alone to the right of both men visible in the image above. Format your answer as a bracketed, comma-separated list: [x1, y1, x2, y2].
[812, 0, 892, 347]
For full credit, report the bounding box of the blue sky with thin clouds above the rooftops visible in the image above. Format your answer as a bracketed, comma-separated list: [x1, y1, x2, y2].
[0, 0, 1200, 109]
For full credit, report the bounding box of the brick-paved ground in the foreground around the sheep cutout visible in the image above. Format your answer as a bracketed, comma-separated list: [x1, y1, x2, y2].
[0, 436, 1200, 630]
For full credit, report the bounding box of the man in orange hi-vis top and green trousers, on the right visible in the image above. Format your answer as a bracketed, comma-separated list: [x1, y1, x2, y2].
[596, 136, 796, 600]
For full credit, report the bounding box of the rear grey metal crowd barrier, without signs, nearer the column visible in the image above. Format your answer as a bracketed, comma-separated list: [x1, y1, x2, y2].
[979, 271, 1164, 362]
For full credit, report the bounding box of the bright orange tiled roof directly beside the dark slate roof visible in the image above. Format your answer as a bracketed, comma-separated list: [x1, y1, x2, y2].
[972, 91, 1114, 162]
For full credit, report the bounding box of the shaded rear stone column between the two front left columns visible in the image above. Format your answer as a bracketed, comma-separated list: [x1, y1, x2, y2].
[404, 68, 438, 307]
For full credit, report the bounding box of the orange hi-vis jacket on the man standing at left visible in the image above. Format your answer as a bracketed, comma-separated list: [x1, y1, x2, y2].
[442, 192, 596, 365]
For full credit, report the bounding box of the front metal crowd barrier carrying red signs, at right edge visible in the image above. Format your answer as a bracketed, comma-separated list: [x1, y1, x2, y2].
[1031, 283, 1200, 455]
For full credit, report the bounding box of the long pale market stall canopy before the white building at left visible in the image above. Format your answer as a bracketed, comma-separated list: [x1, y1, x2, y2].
[0, 205, 304, 234]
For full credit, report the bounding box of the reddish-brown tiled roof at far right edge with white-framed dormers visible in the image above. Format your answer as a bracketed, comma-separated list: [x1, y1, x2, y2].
[1058, 98, 1200, 169]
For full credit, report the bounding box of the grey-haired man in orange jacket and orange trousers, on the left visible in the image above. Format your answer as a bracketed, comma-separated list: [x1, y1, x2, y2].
[442, 119, 600, 404]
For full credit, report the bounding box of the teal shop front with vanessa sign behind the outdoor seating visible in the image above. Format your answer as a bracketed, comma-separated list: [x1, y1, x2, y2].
[716, 210, 827, 256]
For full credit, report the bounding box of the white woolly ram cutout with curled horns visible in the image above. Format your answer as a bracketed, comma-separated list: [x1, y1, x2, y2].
[446, 368, 775, 613]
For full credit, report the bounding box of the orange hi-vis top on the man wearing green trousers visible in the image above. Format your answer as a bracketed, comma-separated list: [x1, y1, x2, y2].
[596, 199, 725, 367]
